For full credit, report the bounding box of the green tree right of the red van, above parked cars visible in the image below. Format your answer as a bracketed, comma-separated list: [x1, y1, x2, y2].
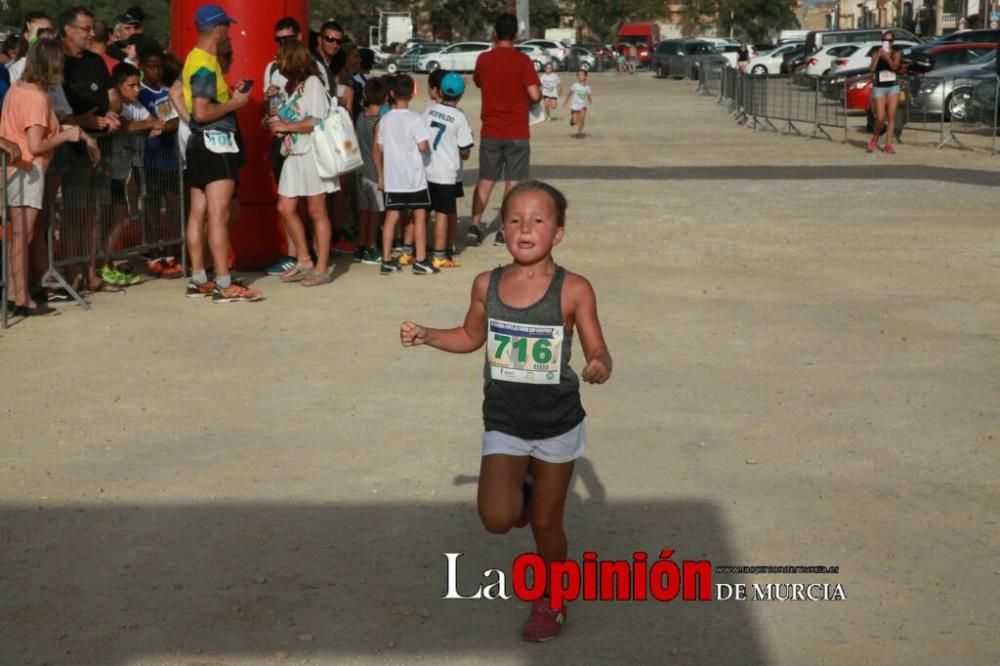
[684, 0, 799, 41]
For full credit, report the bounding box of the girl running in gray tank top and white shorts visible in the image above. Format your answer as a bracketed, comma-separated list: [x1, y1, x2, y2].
[400, 181, 612, 641]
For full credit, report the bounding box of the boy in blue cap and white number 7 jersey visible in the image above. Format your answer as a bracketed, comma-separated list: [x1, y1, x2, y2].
[424, 70, 473, 268]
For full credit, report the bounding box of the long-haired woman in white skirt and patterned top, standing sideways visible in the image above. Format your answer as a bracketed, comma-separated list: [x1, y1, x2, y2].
[268, 40, 340, 287]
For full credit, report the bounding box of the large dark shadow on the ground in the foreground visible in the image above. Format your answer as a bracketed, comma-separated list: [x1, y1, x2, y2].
[0, 463, 767, 665]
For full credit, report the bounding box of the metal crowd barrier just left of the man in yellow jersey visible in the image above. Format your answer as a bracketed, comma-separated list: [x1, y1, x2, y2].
[42, 132, 187, 308]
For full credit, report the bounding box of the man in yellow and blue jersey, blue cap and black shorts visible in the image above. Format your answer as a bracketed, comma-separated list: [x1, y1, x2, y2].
[181, 5, 263, 303]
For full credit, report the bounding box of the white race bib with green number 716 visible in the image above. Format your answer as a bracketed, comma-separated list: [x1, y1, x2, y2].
[486, 319, 564, 384]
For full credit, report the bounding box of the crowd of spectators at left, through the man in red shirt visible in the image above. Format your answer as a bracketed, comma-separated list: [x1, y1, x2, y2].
[0, 4, 541, 316]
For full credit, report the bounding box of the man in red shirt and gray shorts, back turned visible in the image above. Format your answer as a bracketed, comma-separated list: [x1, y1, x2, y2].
[467, 14, 542, 245]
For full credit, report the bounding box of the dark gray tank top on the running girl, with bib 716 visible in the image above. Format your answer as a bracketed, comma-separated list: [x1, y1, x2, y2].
[483, 266, 586, 439]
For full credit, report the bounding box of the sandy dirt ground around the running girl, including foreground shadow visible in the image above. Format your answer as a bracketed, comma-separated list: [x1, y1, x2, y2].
[0, 73, 1000, 666]
